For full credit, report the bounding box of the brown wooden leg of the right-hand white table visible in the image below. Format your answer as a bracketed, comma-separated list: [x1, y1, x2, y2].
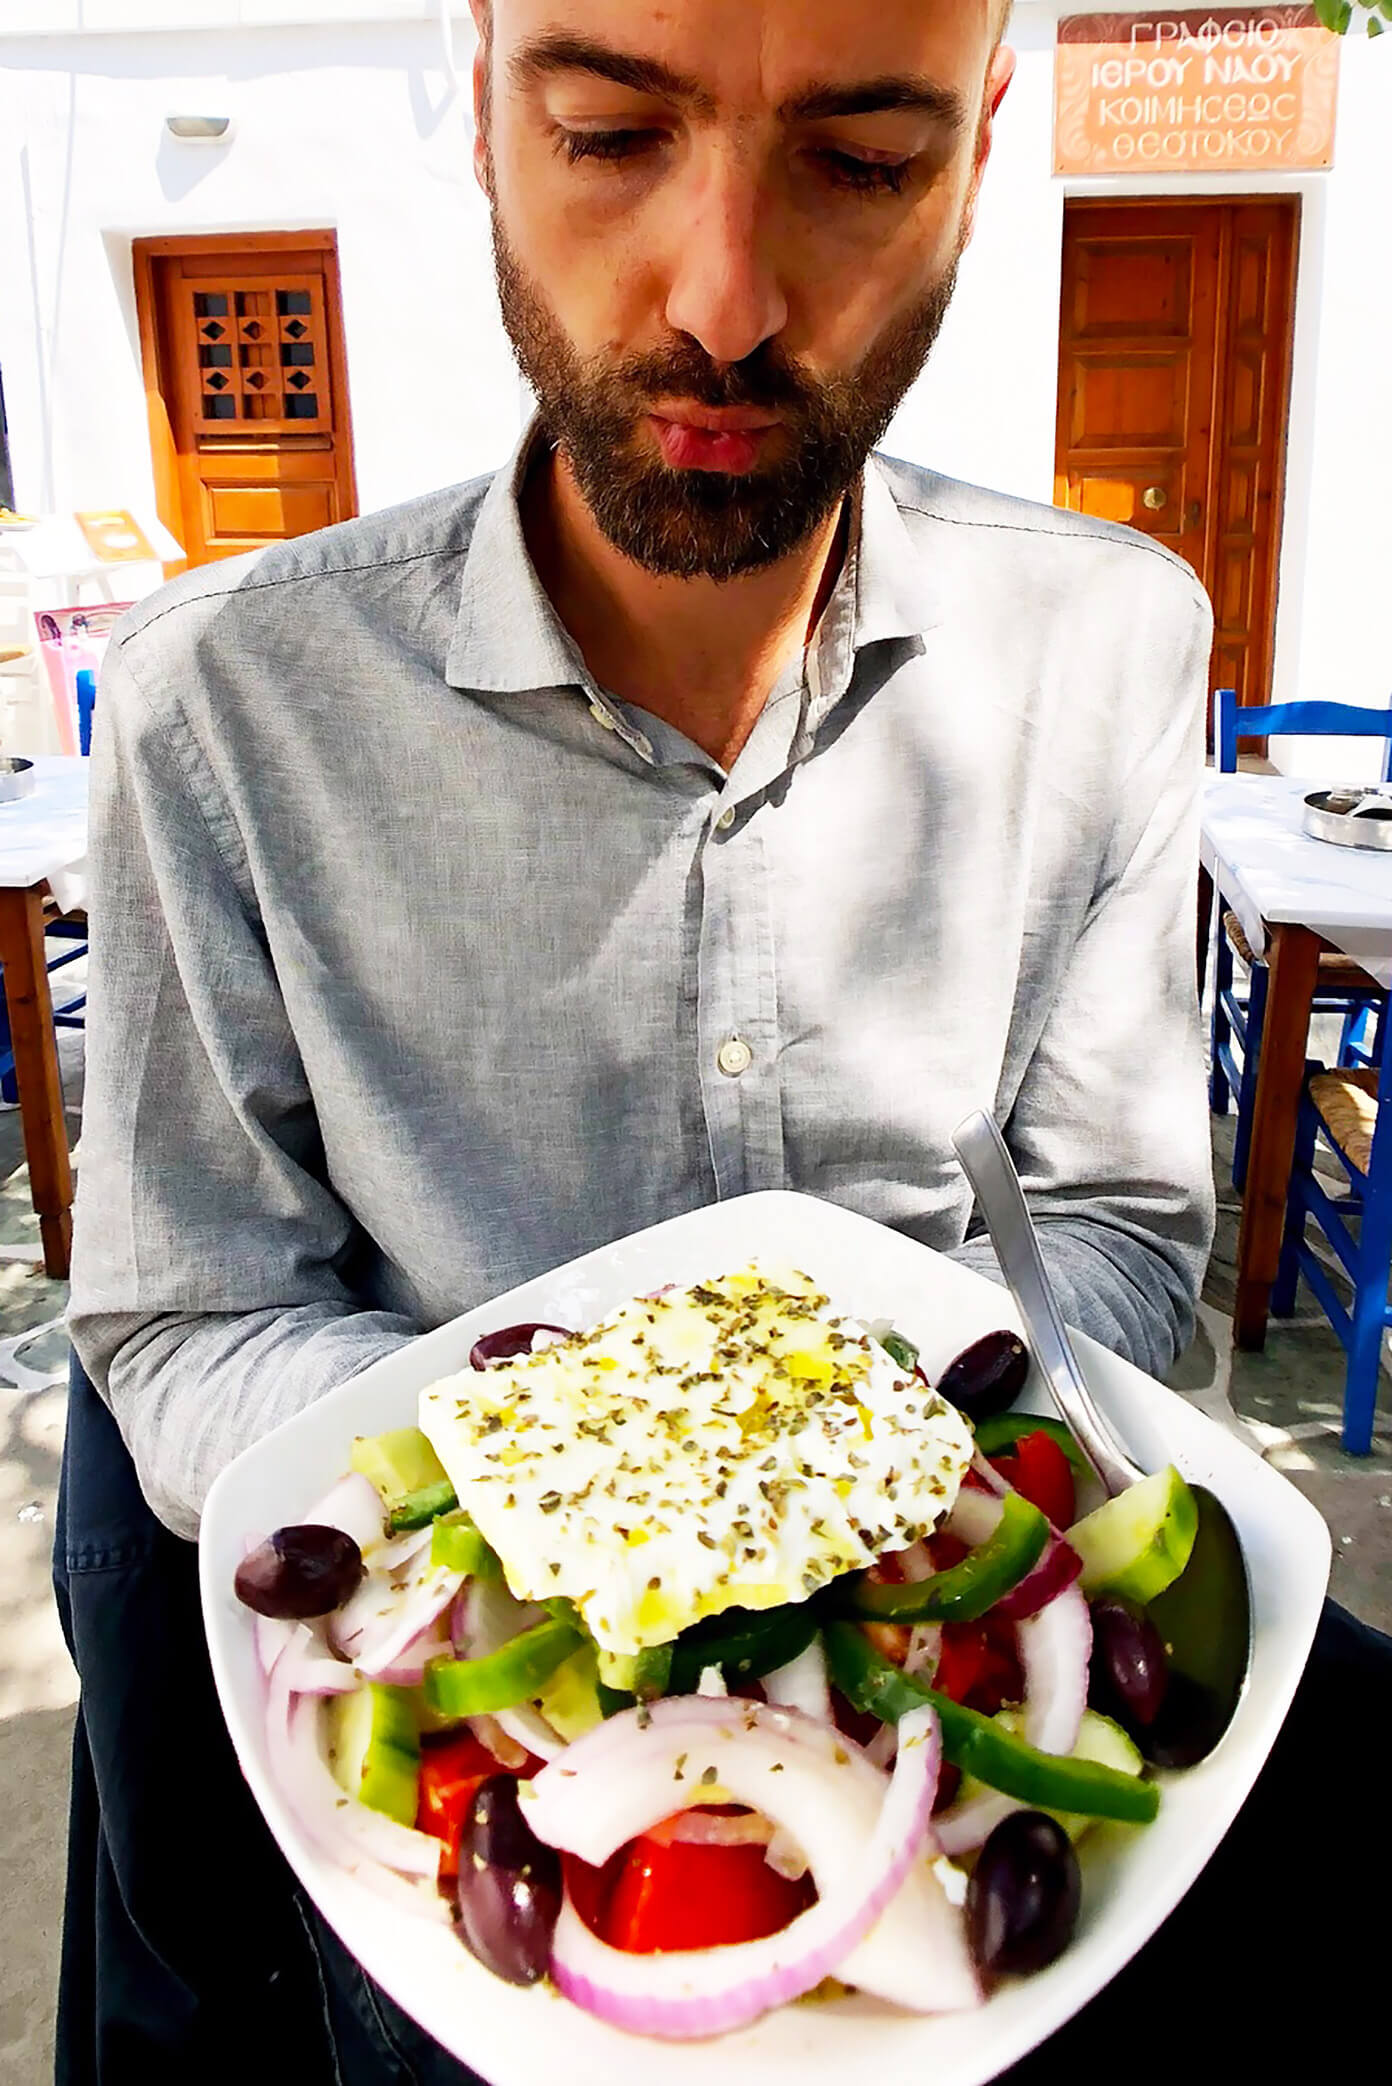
[1233, 924, 1321, 1350]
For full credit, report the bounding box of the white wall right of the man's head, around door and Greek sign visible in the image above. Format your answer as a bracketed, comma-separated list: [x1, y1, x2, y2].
[887, 0, 1392, 780]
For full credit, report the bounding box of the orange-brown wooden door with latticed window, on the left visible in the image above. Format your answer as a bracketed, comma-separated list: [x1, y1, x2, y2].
[136, 232, 357, 569]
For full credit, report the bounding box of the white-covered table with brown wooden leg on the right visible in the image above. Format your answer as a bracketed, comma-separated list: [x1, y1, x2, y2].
[1200, 774, 1392, 1348]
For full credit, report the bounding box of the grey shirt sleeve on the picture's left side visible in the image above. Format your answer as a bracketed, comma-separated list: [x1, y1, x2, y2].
[69, 642, 419, 1537]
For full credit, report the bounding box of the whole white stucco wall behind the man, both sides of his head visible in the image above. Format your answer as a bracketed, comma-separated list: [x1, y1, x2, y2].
[0, 0, 1392, 774]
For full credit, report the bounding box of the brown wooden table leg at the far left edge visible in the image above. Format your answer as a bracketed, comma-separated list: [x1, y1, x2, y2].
[0, 887, 73, 1279]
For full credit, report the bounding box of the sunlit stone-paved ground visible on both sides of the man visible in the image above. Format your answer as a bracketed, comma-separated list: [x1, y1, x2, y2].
[0, 1013, 1392, 2086]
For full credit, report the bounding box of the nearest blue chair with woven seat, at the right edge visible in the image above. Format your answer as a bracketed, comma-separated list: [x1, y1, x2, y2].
[1271, 1022, 1392, 1456]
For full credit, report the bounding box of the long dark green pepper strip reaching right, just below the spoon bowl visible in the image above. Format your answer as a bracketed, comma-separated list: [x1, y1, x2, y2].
[822, 1623, 1160, 1825]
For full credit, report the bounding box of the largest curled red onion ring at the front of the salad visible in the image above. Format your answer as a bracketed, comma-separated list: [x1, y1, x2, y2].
[524, 1698, 960, 2038]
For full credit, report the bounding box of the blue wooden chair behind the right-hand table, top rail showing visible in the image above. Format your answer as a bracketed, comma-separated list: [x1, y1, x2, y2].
[1208, 688, 1392, 1189]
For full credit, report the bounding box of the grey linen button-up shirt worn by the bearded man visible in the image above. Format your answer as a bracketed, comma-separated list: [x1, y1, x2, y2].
[71, 427, 1213, 1535]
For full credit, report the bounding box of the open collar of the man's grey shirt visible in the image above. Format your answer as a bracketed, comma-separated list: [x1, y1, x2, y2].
[445, 421, 937, 705]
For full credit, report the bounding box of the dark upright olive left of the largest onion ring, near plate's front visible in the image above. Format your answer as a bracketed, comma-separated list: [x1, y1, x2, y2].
[455, 1775, 561, 1984]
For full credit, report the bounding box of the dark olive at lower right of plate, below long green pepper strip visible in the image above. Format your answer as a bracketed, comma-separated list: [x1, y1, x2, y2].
[966, 1811, 1083, 1975]
